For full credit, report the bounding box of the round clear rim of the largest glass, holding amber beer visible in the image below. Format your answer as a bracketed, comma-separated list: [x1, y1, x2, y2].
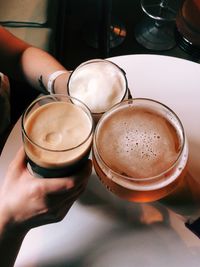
[93, 97, 187, 182]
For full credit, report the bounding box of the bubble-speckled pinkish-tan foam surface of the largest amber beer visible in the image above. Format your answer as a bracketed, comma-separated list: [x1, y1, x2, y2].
[96, 105, 179, 180]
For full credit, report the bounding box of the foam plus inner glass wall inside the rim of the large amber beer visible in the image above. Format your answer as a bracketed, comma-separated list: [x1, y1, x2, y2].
[94, 99, 185, 183]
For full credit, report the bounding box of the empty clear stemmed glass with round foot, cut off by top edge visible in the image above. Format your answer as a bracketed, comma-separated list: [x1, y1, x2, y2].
[135, 0, 180, 51]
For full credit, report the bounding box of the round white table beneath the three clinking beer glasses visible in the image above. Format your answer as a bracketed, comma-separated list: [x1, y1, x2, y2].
[0, 55, 200, 267]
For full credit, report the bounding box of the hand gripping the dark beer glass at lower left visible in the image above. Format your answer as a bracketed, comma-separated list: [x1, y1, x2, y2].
[0, 148, 91, 238]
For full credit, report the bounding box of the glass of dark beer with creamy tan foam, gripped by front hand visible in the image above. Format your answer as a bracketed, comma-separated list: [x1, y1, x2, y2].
[21, 94, 93, 177]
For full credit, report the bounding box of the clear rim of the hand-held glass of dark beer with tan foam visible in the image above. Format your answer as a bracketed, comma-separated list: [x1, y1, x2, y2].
[21, 94, 94, 153]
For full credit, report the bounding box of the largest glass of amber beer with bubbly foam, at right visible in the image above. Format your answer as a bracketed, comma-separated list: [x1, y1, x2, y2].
[93, 98, 188, 202]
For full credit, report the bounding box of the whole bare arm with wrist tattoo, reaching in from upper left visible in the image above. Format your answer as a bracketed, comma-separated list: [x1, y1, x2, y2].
[0, 27, 69, 93]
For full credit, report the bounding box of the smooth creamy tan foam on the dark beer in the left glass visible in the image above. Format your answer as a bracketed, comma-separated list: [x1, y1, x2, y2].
[24, 95, 92, 168]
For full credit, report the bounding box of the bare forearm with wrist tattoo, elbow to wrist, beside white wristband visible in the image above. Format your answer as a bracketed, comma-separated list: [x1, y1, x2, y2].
[21, 47, 69, 93]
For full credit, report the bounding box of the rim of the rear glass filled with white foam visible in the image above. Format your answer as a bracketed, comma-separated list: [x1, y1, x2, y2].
[67, 58, 129, 113]
